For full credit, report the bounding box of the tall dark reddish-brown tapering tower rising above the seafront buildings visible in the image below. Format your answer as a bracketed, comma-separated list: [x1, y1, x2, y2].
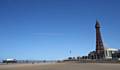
[95, 20, 104, 59]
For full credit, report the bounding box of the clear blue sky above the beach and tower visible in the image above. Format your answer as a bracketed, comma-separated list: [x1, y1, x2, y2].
[0, 0, 120, 60]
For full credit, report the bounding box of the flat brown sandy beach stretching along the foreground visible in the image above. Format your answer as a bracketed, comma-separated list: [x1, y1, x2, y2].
[0, 63, 120, 70]
